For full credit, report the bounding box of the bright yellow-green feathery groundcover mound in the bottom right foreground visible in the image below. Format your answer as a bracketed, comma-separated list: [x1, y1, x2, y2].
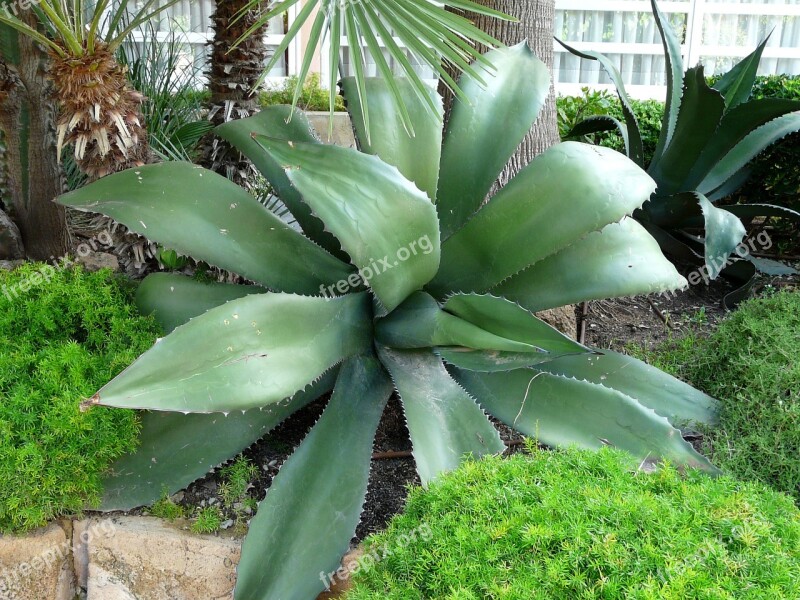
[347, 448, 800, 600]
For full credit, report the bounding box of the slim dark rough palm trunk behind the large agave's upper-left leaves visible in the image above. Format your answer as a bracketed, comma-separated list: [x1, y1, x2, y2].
[203, 0, 267, 187]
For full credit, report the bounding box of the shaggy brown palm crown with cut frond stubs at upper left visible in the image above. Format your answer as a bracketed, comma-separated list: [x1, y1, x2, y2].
[0, 0, 183, 179]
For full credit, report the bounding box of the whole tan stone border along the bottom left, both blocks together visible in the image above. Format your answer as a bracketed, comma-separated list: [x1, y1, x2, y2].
[0, 517, 350, 600]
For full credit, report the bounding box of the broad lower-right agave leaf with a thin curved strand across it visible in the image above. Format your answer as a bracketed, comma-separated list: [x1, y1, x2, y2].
[455, 369, 717, 472]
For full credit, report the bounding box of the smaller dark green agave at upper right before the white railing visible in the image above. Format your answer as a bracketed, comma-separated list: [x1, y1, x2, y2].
[559, 0, 800, 302]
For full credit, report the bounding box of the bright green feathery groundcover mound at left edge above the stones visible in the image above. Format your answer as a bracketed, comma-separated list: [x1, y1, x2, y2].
[0, 264, 158, 531]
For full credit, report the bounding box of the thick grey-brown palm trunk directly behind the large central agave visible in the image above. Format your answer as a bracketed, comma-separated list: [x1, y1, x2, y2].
[440, 0, 578, 338]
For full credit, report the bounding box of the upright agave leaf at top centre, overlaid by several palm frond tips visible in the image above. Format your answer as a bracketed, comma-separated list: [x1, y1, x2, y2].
[341, 77, 443, 201]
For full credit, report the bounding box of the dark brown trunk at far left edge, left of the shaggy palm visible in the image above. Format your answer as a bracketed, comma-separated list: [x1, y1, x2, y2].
[0, 18, 69, 260]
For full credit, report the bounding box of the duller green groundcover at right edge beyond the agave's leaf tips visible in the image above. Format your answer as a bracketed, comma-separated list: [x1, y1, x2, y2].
[629, 291, 800, 502]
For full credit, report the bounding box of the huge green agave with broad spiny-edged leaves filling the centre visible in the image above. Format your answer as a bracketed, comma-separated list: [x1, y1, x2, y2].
[60, 44, 715, 600]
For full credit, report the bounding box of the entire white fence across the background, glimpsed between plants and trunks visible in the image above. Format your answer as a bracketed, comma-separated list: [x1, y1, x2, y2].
[131, 0, 800, 97]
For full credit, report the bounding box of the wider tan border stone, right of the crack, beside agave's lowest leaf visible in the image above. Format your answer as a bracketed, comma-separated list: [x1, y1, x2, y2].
[85, 517, 241, 600]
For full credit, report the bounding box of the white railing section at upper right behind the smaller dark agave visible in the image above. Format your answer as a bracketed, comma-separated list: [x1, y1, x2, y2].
[554, 0, 800, 98]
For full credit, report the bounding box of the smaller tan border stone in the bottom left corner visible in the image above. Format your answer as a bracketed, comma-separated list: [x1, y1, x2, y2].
[0, 523, 75, 600]
